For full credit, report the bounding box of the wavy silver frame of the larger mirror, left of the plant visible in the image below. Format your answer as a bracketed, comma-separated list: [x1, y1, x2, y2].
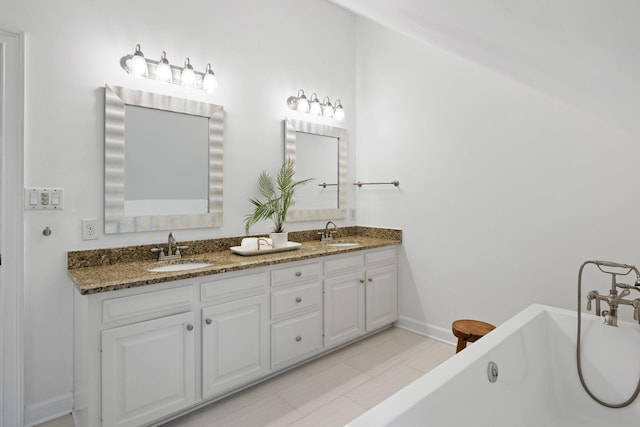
[104, 85, 224, 234]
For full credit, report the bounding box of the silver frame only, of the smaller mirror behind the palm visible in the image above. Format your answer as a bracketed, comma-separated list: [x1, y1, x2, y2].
[284, 119, 349, 222]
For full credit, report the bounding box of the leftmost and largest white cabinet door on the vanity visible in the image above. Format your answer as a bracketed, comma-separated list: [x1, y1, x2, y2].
[102, 312, 196, 426]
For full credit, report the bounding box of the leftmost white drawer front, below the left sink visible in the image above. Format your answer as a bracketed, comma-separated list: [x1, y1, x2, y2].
[102, 286, 193, 323]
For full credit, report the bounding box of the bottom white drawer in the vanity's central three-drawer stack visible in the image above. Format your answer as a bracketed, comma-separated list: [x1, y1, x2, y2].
[271, 311, 322, 369]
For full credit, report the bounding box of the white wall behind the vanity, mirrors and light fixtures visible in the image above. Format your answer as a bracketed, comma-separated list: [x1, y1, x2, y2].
[0, 0, 355, 423]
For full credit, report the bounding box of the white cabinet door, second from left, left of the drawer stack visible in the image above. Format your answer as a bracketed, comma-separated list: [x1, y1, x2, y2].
[202, 294, 269, 399]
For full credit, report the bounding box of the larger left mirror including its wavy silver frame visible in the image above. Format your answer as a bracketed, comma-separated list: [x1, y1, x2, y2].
[104, 85, 224, 234]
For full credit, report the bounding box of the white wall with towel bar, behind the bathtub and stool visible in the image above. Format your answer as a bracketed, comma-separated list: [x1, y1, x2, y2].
[356, 18, 640, 340]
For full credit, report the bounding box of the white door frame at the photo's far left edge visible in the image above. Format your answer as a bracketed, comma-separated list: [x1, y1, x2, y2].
[0, 29, 24, 427]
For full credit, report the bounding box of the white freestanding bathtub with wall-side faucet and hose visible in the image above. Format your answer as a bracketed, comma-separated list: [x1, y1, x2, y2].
[349, 305, 640, 427]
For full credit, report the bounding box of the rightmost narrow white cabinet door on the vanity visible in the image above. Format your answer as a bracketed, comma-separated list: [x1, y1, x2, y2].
[366, 265, 398, 332]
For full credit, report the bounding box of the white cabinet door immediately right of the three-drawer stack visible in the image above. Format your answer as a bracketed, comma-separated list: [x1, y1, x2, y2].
[324, 272, 365, 348]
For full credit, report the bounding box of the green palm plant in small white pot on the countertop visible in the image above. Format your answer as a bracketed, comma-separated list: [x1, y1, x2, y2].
[244, 159, 312, 248]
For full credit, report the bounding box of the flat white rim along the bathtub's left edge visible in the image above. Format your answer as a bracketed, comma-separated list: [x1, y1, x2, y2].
[347, 304, 584, 427]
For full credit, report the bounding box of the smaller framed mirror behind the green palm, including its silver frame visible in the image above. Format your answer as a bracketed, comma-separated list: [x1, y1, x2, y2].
[284, 119, 348, 221]
